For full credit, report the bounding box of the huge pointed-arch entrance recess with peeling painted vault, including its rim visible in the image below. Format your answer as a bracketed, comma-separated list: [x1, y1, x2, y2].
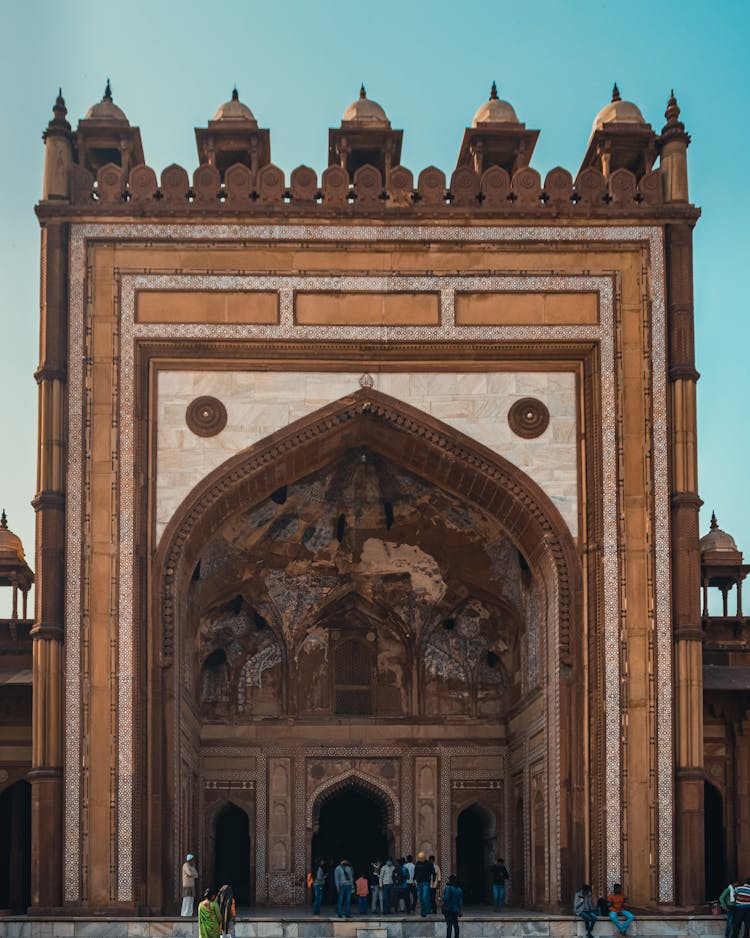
[149, 390, 585, 905]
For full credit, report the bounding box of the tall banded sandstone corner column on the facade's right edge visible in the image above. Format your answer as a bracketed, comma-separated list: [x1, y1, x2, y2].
[666, 223, 705, 906]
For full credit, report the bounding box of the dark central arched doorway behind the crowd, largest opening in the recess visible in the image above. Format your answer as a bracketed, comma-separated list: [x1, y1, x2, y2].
[311, 787, 391, 902]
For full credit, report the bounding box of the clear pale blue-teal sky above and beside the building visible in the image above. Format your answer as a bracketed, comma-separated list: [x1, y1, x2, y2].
[0, 0, 750, 610]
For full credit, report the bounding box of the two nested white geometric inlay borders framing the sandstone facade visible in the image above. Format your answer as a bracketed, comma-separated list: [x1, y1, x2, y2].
[65, 223, 673, 902]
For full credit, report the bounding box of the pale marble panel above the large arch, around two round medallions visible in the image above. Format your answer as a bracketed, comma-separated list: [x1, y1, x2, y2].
[156, 371, 578, 541]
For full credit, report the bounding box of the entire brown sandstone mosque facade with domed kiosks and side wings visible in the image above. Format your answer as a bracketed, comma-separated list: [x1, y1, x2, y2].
[0, 78, 750, 914]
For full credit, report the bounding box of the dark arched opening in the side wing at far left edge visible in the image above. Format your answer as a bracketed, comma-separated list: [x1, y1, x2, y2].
[0, 781, 31, 912]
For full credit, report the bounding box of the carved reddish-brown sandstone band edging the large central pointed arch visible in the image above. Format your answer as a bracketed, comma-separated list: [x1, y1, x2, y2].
[150, 389, 586, 901]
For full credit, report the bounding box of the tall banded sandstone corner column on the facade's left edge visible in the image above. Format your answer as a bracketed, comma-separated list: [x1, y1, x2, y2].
[29, 223, 68, 909]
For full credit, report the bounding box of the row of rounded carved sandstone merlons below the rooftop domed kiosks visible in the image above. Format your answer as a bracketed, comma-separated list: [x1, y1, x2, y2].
[72, 163, 662, 210]
